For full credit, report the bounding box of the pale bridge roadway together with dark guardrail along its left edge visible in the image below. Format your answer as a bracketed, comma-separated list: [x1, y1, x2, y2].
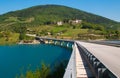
[76, 41, 120, 78]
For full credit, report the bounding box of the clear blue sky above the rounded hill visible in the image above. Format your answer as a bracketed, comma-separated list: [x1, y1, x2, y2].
[0, 0, 120, 22]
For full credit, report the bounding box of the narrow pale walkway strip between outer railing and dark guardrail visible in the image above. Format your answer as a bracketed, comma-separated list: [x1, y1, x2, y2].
[75, 45, 93, 78]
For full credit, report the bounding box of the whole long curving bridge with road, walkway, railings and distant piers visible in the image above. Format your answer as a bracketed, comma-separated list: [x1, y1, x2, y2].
[36, 37, 120, 78]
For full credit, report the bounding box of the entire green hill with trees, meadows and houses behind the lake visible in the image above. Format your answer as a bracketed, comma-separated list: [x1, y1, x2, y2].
[0, 5, 120, 44]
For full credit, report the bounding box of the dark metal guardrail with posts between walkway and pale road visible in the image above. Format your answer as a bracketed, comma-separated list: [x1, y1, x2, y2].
[77, 43, 117, 78]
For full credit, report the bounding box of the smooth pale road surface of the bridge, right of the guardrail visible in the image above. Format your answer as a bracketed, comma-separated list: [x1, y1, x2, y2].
[77, 41, 120, 77]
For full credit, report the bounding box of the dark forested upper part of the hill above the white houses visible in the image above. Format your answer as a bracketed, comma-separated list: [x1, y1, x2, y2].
[0, 5, 120, 29]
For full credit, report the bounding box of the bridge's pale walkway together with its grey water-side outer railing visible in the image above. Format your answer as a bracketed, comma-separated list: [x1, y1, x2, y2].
[63, 44, 93, 78]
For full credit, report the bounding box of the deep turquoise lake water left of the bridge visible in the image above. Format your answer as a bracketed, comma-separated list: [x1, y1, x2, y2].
[0, 44, 71, 78]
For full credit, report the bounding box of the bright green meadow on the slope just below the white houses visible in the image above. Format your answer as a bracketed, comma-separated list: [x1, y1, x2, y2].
[29, 25, 88, 38]
